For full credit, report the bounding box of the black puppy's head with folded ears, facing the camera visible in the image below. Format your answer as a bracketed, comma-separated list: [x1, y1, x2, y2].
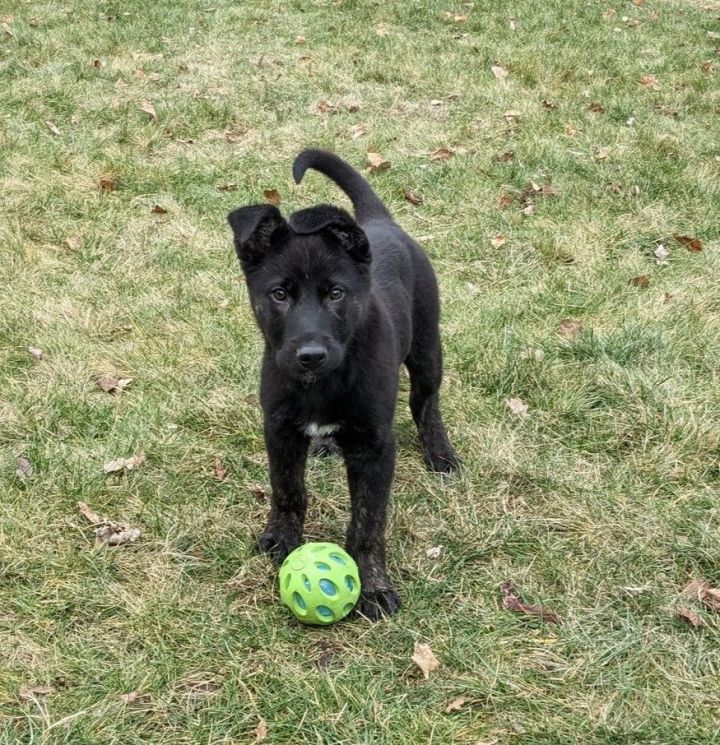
[228, 205, 370, 383]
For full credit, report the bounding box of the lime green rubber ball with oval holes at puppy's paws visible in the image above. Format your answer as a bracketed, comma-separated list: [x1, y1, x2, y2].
[280, 543, 360, 626]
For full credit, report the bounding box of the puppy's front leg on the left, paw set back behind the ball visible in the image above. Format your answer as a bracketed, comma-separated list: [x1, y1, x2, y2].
[258, 424, 308, 563]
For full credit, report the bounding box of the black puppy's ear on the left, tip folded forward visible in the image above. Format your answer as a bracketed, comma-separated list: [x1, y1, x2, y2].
[228, 204, 290, 272]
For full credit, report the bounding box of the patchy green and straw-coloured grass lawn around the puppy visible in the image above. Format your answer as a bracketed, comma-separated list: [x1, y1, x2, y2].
[0, 0, 720, 745]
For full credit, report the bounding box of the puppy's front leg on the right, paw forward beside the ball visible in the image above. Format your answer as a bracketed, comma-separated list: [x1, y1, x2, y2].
[343, 433, 400, 620]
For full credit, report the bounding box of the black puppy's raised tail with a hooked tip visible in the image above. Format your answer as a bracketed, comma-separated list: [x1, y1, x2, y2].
[293, 149, 392, 223]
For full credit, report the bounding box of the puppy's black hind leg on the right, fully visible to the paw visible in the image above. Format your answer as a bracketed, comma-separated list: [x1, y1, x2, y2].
[405, 326, 460, 473]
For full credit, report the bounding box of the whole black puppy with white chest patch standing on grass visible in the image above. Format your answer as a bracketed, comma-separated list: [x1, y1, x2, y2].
[228, 150, 458, 619]
